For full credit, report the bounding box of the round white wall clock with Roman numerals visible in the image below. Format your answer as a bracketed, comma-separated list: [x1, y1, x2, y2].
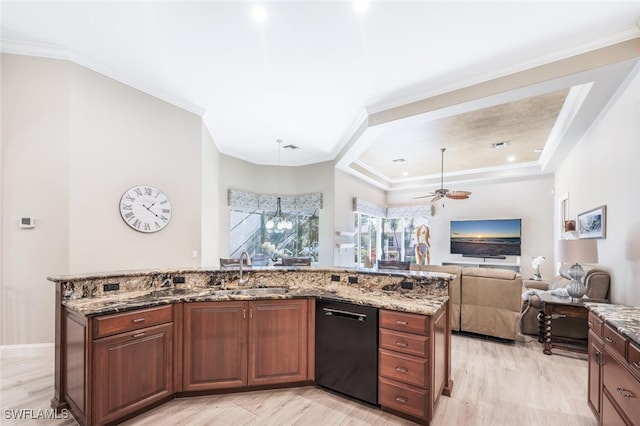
[120, 185, 171, 232]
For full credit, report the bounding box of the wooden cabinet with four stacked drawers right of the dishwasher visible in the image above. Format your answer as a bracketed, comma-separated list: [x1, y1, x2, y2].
[378, 307, 450, 424]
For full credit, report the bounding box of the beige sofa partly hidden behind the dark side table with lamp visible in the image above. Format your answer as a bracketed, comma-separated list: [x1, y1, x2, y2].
[520, 266, 611, 339]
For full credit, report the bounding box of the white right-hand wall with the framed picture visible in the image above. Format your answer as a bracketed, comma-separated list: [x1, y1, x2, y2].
[556, 66, 640, 306]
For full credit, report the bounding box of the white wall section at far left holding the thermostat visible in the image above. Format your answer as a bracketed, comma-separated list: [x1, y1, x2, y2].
[0, 55, 71, 344]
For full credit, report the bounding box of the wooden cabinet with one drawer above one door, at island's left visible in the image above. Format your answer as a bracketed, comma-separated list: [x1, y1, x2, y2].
[89, 306, 173, 425]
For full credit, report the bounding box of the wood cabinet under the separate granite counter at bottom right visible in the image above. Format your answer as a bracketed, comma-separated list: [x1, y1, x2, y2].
[589, 313, 640, 426]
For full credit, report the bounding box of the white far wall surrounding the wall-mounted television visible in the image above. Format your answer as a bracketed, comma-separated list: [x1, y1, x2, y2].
[387, 175, 555, 278]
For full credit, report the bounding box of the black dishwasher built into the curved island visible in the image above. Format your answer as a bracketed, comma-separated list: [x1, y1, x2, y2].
[316, 299, 378, 405]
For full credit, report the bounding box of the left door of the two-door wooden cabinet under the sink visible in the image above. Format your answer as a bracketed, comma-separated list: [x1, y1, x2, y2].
[183, 302, 248, 391]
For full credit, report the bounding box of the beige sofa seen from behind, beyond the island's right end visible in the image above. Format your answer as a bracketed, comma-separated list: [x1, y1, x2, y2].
[411, 265, 522, 340]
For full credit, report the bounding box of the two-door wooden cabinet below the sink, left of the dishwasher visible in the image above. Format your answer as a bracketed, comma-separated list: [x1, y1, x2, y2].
[183, 299, 309, 391]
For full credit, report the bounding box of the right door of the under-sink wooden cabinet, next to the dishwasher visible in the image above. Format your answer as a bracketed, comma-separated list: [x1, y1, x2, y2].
[249, 299, 308, 385]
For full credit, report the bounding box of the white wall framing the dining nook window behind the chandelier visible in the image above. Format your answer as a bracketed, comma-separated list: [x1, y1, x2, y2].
[215, 153, 334, 266]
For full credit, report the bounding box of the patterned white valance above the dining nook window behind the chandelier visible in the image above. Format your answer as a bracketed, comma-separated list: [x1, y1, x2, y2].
[227, 189, 322, 211]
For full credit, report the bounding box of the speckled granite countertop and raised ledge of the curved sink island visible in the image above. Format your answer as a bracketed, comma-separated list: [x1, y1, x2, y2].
[48, 267, 453, 316]
